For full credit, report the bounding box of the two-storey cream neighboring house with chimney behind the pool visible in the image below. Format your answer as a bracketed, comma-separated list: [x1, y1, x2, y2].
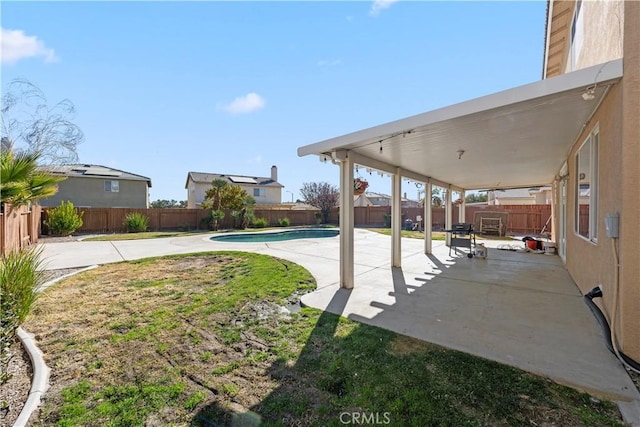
[185, 166, 284, 209]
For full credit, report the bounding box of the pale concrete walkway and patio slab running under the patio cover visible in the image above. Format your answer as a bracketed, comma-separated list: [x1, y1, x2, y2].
[42, 229, 640, 410]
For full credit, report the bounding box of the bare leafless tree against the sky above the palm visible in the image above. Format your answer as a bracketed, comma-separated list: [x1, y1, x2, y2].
[0, 79, 84, 165]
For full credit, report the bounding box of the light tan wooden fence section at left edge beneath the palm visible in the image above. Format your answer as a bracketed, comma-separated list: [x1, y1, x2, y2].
[0, 203, 41, 254]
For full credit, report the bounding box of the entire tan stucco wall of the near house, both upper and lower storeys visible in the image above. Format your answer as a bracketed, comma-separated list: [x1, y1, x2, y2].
[554, 0, 640, 368]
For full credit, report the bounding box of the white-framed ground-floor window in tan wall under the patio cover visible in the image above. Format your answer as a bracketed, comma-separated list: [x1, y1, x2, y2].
[575, 128, 599, 242]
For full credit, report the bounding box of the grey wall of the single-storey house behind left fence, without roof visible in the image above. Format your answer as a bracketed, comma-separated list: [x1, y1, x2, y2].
[39, 177, 149, 208]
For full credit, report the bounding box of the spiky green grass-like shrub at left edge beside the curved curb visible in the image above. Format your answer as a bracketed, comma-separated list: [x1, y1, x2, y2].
[0, 249, 45, 385]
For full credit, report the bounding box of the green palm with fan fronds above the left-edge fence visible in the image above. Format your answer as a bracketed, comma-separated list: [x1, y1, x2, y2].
[0, 150, 64, 206]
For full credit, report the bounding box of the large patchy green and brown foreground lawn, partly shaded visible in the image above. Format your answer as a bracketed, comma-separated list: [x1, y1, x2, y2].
[24, 252, 622, 427]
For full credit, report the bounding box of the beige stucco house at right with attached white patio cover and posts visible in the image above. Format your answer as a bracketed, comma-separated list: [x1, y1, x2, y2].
[298, 0, 640, 362]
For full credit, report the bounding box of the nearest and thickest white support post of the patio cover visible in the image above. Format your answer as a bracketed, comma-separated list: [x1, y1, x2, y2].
[335, 151, 355, 289]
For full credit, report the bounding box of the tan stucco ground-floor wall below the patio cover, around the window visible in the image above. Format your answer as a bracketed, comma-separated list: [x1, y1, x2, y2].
[566, 81, 640, 360]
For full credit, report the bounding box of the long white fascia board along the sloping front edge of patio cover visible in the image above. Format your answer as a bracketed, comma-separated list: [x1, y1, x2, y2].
[298, 58, 622, 157]
